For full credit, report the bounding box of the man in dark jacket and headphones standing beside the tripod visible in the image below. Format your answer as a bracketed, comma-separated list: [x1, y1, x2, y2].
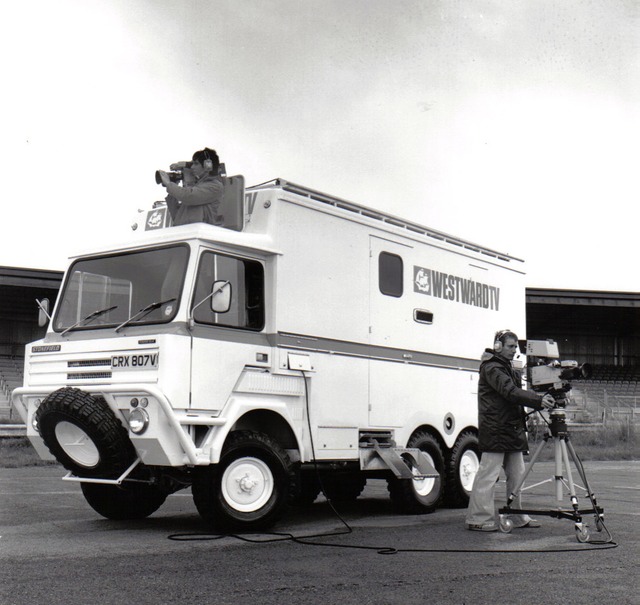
[465, 330, 555, 532]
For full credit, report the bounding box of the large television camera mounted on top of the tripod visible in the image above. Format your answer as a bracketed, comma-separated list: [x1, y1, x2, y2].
[526, 339, 592, 408]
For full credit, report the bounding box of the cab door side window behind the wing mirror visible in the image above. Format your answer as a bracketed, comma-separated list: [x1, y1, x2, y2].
[192, 252, 265, 331]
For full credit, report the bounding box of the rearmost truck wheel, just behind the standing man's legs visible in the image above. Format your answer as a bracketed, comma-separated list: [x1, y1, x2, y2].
[445, 431, 480, 507]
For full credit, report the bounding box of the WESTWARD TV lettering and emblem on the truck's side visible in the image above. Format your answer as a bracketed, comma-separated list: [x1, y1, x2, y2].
[413, 265, 500, 311]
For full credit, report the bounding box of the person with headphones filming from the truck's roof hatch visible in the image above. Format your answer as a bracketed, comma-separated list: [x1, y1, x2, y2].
[158, 147, 224, 226]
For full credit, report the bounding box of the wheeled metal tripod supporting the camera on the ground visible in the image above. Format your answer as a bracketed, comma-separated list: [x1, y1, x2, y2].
[498, 408, 611, 542]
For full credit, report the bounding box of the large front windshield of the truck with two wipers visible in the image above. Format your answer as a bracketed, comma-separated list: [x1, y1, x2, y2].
[53, 245, 189, 332]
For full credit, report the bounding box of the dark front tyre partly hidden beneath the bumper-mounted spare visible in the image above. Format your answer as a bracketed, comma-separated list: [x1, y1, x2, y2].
[80, 482, 168, 521]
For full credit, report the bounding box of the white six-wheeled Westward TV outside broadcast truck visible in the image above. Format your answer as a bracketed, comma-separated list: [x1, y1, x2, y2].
[12, 176, 525, 530]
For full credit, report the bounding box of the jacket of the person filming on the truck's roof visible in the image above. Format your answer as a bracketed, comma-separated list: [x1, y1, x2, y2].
[165, 174, 224, 227]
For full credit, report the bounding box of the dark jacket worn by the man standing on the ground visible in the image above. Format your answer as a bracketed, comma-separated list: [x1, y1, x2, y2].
[478, 349, 542, 452]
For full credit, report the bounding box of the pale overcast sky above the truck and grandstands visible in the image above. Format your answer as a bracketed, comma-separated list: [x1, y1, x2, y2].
[0, 0, 640, 291]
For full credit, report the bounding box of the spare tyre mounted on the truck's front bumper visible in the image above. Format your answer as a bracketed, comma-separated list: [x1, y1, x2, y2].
[36, 387, 136, 479]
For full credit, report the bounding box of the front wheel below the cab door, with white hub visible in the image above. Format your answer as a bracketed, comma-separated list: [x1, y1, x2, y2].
[191, 431, 294, 531]
